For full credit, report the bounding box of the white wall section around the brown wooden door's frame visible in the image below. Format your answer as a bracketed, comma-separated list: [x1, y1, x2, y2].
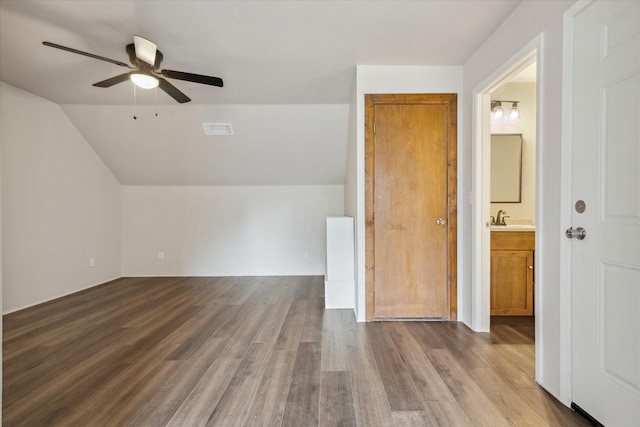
[347, 65, 464, 321]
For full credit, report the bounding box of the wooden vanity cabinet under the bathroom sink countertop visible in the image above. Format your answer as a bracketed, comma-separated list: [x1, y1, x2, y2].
[491, 231, 535, 316]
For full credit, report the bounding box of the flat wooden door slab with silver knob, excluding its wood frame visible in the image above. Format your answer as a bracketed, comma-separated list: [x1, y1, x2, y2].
[374, 105, 448, 318]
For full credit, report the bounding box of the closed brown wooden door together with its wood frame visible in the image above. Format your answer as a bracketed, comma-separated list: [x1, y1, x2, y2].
[365, 94, 457, 320]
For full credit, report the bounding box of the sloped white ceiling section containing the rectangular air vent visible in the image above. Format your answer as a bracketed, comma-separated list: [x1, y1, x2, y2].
[62, 104, 349, 185]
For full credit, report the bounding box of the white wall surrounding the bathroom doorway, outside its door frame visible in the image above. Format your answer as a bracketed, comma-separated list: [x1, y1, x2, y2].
[458, 1, 574, 403]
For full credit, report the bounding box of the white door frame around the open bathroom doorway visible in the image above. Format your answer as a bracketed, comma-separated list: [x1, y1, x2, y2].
[471, 34, 544, 368]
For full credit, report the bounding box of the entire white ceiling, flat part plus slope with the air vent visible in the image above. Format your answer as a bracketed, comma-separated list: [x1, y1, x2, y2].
[0, 0, 519, 185]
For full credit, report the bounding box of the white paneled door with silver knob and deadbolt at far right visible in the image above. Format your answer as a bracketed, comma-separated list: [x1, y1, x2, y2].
[571, 0, 640, 426]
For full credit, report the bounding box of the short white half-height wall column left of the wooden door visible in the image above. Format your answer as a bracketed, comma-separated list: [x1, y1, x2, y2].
[324, 217, 355, 308]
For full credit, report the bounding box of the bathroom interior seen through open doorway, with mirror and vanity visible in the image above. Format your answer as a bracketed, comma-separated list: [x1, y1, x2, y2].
[485, 61, 537, 332]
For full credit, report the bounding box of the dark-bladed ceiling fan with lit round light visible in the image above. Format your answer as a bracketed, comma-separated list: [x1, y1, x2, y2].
[42, 36, 223, 104]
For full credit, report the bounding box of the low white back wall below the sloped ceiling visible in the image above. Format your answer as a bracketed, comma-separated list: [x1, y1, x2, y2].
[122, 185, 344, 276]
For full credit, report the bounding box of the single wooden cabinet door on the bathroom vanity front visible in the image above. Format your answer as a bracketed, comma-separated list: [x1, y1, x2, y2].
[491, 251, 533, 316]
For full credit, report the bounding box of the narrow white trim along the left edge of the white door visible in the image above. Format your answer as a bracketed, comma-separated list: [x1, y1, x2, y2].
[559, 0, 591, 406]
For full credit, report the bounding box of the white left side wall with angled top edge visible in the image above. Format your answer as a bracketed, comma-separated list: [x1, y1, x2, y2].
[0, 82, 120, 313]
